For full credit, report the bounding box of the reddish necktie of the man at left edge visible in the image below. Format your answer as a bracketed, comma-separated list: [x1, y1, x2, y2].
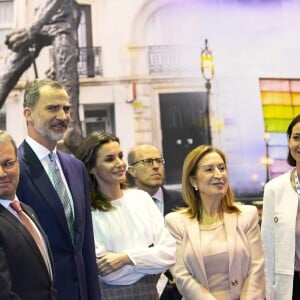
[10, 200, 51, 274]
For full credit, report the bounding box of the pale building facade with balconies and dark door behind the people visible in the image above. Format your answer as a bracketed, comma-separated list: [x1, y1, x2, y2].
[0, 0, 300, 193]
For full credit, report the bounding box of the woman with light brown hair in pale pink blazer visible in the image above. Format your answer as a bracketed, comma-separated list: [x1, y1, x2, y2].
[165, 145, 265, 300]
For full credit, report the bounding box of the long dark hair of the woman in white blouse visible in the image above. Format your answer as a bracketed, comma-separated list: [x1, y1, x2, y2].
[76, 131, 126, 211]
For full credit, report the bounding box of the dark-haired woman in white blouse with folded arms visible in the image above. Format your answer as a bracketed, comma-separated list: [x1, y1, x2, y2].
[77, 131, 175, 300]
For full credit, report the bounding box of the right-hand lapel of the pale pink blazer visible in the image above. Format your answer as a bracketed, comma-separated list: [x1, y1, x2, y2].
[224, 213, 237, 270]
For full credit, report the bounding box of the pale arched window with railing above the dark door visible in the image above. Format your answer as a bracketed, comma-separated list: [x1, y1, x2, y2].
[144, 1, 203, 76]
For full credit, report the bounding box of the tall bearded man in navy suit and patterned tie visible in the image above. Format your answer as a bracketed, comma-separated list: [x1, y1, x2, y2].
[17, 79, 100, 300]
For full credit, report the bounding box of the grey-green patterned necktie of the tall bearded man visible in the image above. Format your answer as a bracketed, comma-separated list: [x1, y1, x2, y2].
[48, 152, 75, 242]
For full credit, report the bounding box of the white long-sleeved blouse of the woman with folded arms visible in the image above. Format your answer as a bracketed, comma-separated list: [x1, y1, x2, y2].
[92, 189, 176, 285]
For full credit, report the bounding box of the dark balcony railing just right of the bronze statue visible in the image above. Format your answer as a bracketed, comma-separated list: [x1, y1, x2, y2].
[77, 47, 103, 77]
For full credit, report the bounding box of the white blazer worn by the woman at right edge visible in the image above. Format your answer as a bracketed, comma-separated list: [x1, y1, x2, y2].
[261, 171, 298, 300]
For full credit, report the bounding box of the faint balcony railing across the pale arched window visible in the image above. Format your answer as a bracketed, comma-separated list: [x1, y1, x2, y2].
[148, 45, 201, 75]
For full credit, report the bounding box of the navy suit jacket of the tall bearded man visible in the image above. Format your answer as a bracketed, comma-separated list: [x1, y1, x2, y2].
[17, 141, 100, 300]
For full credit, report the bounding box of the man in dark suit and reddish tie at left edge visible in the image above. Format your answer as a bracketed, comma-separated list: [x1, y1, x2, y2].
[0, 130, 56, 300]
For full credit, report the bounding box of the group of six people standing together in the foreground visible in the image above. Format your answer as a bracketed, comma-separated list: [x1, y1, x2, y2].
[0, 79, 300, 300]
